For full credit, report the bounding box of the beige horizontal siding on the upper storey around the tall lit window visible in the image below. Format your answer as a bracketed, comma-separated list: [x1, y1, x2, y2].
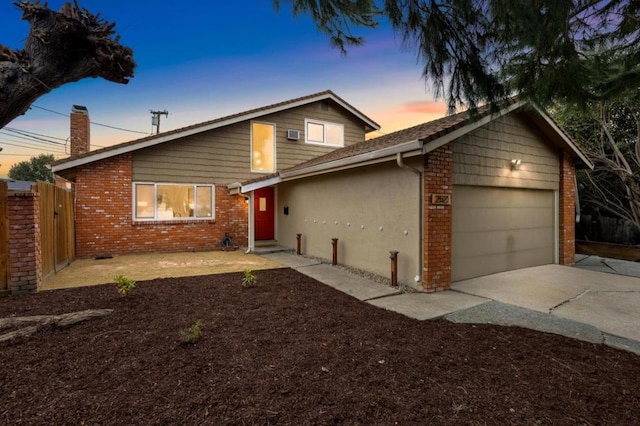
[133, 102, 365, 184]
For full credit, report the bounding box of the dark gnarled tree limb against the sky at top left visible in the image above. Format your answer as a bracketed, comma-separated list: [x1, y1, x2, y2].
[0, 0, 136, 128]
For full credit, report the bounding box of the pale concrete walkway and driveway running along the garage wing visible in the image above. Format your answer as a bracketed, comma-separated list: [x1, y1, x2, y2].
[263, 253, 640, 355]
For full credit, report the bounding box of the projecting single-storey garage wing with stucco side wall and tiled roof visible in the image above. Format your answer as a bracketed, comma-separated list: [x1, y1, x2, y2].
[234, 99, 593, 292]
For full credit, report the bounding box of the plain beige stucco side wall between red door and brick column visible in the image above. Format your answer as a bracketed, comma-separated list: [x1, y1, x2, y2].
[277, 157, 422, 286]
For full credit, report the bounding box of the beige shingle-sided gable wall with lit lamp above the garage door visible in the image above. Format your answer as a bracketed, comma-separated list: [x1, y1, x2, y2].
[453, 114, 560, 190]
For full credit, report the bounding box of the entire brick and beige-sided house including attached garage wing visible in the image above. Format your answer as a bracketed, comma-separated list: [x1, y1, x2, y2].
[53, 91, 592, 292]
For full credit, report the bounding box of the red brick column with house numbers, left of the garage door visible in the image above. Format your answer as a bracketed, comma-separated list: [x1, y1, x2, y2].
[422, 145, 453, 293]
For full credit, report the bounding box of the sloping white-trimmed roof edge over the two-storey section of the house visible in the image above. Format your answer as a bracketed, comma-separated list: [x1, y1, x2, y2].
[51, 91, 380, 173]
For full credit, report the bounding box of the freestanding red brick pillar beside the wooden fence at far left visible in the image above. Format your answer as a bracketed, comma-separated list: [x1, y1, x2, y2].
[7, 192, 42, 294]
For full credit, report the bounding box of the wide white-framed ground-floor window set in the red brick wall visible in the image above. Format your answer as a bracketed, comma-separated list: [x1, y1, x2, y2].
[133, 183, 215, 220]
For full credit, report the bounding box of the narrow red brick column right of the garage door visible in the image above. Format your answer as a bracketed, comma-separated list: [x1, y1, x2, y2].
[558, 151, 576, 265]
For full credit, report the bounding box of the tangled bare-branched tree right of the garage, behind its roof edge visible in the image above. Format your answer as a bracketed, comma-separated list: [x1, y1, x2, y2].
[551, 96, 640, 236]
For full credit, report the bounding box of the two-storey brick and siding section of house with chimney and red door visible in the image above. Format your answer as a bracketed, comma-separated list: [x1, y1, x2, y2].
[52, 91, 379, 258]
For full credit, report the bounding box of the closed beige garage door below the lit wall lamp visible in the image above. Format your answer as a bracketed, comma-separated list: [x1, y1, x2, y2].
[451, 186, 555, 281]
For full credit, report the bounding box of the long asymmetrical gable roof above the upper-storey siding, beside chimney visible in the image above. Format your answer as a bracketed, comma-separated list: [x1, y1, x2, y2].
[52, 90, 380, 172]
